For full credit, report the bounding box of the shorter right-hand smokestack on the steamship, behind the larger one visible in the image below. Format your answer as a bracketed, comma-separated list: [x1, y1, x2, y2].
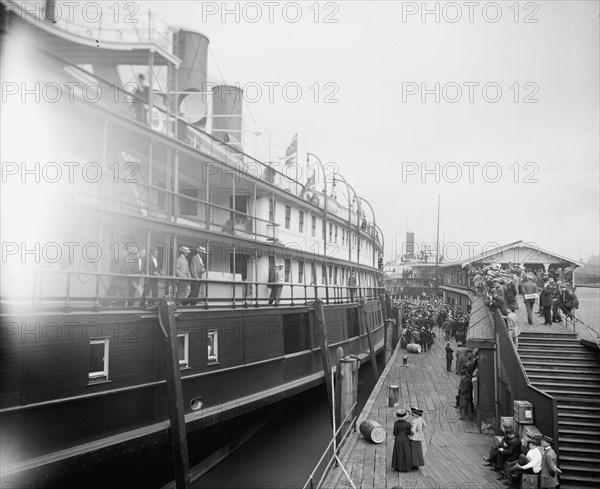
[212, 84, 243, 151]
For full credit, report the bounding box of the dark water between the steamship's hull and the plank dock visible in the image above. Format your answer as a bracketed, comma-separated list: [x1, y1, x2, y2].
[193, 355, 384, 489]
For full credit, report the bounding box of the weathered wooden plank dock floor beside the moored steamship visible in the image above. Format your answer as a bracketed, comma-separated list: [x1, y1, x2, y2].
[323, 328, 505, 489]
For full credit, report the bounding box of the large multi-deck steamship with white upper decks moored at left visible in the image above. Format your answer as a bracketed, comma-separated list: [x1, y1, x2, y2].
[0, 0, 385, 485]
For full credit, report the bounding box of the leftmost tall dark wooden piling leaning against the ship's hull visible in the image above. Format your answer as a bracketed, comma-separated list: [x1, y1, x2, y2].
[158, 297, 190, 489]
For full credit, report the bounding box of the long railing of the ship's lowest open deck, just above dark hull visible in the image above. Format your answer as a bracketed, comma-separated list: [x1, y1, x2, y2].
[0, 267, 383, 314]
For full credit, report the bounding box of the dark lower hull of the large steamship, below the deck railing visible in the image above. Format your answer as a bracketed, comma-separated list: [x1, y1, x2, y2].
[2, 301, 384, 481]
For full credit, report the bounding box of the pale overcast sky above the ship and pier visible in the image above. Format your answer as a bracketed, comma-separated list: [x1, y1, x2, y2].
[141, 0, 600, 262]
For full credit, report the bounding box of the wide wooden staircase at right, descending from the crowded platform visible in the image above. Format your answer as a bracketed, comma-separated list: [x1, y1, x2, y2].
[518, 333, 600, 489]
